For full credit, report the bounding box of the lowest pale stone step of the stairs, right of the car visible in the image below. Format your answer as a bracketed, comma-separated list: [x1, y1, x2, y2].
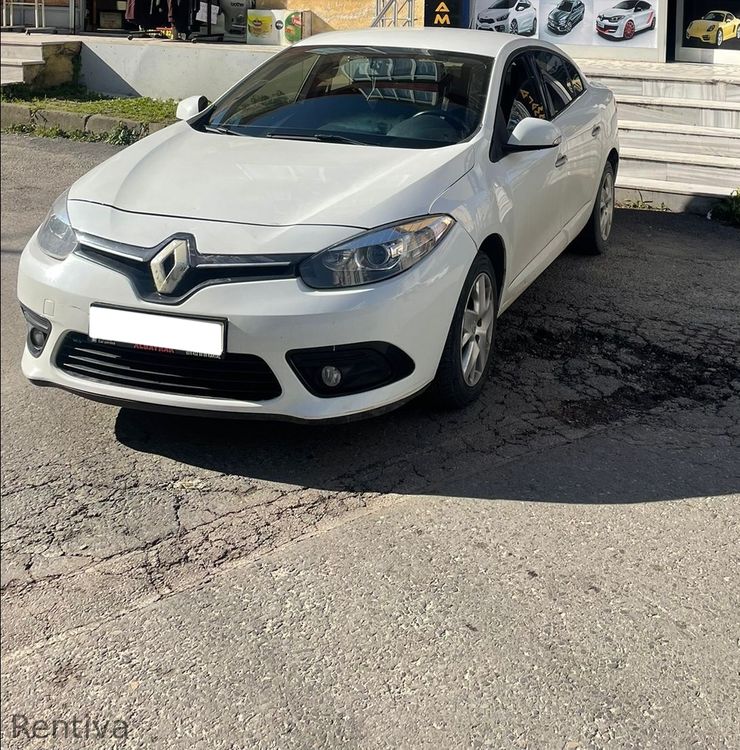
[616, 179, 731, 215]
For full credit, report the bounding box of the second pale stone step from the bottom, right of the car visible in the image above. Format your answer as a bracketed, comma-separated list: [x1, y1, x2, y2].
[619, 148, 740, 191]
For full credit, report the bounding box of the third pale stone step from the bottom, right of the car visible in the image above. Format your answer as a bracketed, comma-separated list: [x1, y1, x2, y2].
[619, 120, 740, 159]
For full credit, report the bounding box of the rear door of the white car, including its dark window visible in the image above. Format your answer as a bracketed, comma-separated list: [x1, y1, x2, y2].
[532, 49, 605, 232]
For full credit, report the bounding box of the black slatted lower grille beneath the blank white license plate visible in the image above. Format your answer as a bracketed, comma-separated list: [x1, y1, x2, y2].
[56, 333, 282, 401]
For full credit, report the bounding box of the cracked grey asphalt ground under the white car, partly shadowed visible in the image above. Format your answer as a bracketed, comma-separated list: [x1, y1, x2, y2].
[0, 135, 740, 750]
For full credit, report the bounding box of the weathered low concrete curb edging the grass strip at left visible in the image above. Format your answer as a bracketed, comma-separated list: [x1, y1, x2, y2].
[0, 102, 172, 135]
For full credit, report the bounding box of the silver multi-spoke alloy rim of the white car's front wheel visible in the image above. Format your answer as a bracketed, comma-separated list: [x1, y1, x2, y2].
[460, 273, 494, 386]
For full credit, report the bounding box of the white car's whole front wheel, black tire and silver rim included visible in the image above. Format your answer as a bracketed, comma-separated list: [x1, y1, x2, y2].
[432, 252, 498, 409]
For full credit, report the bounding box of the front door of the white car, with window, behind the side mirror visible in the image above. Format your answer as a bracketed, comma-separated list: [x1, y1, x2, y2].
[484, 52, 567, 280]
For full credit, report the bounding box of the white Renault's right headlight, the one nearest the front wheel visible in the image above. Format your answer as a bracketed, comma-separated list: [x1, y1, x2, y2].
[299, 215, 455, 289]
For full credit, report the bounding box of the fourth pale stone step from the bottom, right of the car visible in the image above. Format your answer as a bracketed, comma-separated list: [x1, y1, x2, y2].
[616, 94, 740, 128]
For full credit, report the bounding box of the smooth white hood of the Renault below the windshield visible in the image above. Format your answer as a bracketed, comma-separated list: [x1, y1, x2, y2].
[69, 123, 473, 229]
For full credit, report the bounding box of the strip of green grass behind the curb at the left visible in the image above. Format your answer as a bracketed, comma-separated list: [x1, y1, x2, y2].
[0, 83, 177, 122]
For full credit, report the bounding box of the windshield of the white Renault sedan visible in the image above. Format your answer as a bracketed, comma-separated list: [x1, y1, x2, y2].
[204, 47, 493, 148]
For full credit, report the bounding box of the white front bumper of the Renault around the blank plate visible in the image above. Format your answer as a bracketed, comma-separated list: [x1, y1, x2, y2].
[18, 224, 476, 421]
